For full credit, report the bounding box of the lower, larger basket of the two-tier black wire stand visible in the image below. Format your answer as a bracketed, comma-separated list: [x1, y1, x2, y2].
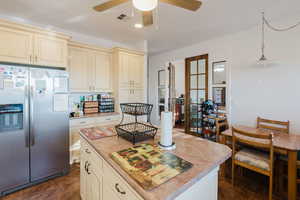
[115, 122, 158, 144]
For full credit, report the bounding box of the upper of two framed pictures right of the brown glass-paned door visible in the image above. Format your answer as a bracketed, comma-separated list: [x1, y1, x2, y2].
[212, 61, 226, 85]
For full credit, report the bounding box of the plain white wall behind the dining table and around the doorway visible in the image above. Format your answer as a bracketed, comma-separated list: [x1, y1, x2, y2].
[149, 15, 300, 134]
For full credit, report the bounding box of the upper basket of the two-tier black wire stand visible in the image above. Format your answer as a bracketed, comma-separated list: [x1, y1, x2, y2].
[120, 103, 153, 116]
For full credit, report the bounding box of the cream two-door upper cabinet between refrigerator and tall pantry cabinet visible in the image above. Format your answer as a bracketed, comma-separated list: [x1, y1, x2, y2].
[68, 42, 112, 92]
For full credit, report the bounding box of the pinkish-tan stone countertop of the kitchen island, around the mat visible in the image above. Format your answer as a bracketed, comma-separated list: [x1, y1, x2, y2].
[80, 129, 231, 200]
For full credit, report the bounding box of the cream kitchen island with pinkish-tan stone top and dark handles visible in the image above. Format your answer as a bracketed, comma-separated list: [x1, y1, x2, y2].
[80, 130, 231, 200]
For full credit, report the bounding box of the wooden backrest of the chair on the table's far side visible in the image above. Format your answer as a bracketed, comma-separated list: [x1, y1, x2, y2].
[257, 117, 290, 134]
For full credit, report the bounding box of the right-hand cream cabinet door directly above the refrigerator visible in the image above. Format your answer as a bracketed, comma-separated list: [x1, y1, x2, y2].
[34, 34, 68, 68]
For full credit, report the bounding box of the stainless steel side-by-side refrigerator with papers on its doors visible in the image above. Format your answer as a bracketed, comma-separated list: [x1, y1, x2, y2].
[0, 64, 69, 196]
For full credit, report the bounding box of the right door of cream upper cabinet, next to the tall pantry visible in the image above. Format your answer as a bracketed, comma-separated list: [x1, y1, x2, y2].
[94, 52, 112, 92]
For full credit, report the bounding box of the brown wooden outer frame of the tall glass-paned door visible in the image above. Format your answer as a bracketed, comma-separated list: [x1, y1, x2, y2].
[184, 54, 209, 136]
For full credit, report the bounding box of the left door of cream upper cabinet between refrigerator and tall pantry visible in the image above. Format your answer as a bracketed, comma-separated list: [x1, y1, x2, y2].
[68, 47, 92, 92]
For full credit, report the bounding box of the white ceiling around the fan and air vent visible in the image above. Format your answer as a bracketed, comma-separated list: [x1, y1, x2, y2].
[0, 0, 300, 54]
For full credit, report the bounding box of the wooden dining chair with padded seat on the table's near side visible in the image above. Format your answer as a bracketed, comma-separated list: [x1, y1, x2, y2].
[232, 127, 274, 200]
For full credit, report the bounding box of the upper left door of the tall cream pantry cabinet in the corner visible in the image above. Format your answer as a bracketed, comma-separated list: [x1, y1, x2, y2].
[119, 52, 130, 88]
